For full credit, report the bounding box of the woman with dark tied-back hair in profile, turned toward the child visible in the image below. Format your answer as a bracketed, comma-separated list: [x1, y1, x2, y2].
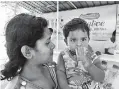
[1, 13, 57, 89]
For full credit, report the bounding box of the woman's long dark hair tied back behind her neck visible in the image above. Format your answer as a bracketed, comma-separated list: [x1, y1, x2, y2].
[1, 13, 48, 80]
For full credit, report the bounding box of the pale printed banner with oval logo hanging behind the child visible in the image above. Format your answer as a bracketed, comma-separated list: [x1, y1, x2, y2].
[58, 5, 116, 53]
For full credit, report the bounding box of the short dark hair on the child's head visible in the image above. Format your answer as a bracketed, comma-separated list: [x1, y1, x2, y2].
[63, 18, 90, 39]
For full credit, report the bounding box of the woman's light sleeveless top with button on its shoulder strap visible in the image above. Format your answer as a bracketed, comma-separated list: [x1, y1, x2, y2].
[5, 64, 58, 89]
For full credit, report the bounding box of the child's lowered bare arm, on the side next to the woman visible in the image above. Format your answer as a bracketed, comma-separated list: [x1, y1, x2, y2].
[57, 52, 70, 89]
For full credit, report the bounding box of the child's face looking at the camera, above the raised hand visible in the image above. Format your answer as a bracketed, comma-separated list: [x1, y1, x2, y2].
[66, 29, 89, 51]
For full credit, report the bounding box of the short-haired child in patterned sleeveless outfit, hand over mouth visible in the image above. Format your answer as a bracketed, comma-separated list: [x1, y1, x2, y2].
[57, 18, 105, 89]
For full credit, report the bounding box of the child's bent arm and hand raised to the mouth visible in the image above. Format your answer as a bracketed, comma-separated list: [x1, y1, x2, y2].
[76, 47, 105, 82]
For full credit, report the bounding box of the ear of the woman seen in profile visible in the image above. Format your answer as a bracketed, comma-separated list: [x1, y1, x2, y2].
[21, 45, 33, 59]
